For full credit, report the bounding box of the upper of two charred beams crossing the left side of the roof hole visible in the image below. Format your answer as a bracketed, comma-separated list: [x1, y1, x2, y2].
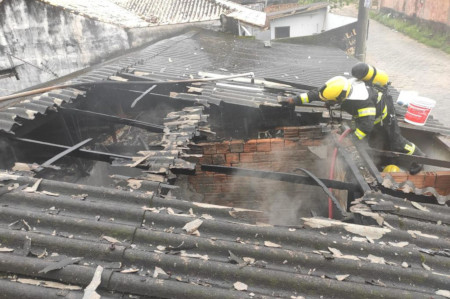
[59, 107, 164, 133]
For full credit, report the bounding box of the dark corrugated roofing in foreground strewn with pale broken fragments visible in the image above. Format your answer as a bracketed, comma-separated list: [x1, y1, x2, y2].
[0, 173, 450, 298]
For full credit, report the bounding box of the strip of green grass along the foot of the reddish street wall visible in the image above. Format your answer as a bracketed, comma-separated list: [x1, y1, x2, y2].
[370, 11, 450, 54]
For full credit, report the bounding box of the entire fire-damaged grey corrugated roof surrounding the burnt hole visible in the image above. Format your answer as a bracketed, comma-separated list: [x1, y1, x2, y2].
[0, 32, 450, 298]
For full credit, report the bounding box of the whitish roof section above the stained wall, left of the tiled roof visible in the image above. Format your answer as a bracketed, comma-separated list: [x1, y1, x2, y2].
[40, 0, 150, 28]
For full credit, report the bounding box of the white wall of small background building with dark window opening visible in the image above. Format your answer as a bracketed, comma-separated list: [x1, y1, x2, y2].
[270, 8, 327, 39]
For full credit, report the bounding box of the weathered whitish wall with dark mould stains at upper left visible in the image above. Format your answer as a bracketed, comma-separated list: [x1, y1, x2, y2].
[0, 0, 192, 95]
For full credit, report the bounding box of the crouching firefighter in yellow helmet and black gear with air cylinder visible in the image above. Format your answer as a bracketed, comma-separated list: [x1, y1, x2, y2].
[279, 63, 425, 174]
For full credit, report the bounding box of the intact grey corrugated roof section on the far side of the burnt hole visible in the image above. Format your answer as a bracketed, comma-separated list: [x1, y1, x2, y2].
[122, 31, 357, 91]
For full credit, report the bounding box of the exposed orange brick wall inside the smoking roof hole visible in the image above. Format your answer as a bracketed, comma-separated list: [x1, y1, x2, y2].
[189, 126, 329, 224]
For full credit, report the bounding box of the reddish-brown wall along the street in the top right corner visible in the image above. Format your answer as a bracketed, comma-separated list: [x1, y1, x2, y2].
[379, 0, 450, 26]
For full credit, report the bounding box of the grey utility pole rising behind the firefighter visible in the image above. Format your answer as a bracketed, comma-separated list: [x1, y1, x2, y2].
[355, 0, 372, 62]
